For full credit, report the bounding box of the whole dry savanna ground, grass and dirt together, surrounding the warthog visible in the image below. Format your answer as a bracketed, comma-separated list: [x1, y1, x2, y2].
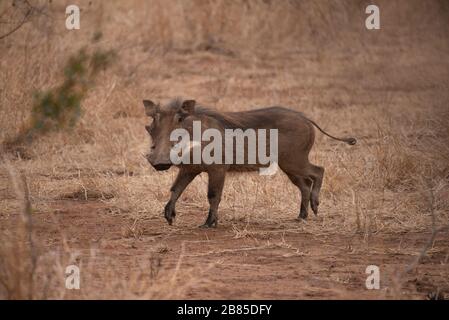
[0, 0, 449, 299]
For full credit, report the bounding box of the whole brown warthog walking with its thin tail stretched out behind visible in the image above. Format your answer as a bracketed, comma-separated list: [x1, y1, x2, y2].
[143, 99, 356, 227]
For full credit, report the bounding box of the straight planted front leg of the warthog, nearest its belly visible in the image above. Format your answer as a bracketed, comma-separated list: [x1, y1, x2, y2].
[200, 169, 226, 228]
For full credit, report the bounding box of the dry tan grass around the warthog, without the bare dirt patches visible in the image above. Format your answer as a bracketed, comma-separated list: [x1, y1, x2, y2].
[0, 0, 449, 298]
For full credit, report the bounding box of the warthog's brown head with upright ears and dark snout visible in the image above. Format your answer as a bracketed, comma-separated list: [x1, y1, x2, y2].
[143, 100, 196, 171]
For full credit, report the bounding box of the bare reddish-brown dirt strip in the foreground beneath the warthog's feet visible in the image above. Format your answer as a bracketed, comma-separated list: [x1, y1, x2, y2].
[21, 200, 449, 299]
